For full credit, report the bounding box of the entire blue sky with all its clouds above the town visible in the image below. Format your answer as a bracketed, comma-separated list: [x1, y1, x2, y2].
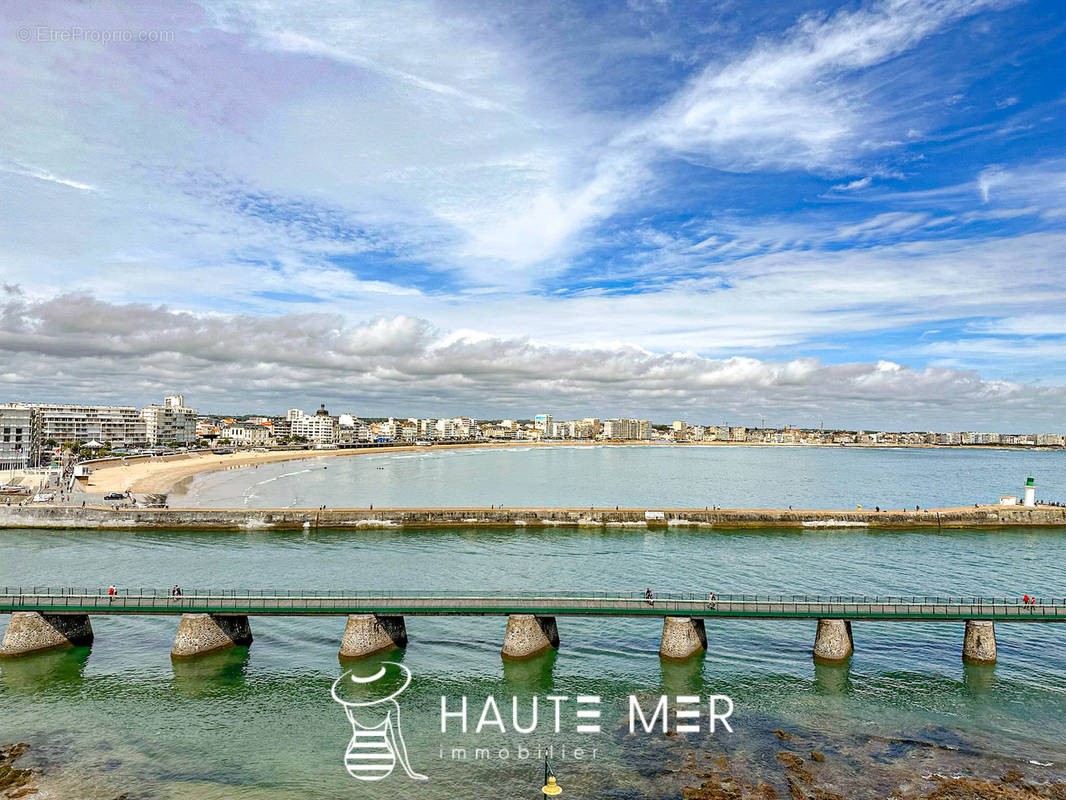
[0, 0, 1066, 430]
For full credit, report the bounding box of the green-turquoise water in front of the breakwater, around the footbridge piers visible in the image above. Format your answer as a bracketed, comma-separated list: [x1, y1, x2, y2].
[0, 522, 1066, 800]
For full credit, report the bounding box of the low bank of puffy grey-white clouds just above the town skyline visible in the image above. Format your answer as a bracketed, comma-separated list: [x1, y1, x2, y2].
[0, 295, 1066, 433]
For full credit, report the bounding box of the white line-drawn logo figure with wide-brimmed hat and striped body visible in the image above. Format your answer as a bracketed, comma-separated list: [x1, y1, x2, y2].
[329, 661, 427, 781]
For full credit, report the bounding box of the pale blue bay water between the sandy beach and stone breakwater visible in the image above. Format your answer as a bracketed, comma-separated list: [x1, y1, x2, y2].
[171, 446, 1066, 509]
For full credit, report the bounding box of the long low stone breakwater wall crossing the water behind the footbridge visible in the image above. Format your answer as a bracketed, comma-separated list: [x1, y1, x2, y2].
[0, 506, 1066, 530]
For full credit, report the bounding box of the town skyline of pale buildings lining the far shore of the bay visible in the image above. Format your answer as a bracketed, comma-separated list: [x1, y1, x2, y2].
[0, 394, 1066, 469]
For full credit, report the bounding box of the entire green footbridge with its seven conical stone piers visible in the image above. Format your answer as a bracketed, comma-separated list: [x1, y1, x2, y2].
[0, 587, 1066, 663]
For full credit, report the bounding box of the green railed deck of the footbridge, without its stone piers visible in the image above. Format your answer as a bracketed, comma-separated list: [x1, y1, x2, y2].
[0, 586, 1066, 622]
